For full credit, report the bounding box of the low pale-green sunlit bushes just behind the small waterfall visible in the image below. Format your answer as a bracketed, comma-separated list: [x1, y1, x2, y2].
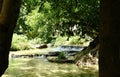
[54, 36, 92, 46]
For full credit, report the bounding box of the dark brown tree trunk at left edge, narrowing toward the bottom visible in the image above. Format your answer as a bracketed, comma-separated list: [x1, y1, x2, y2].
[0, 0, 21, 76]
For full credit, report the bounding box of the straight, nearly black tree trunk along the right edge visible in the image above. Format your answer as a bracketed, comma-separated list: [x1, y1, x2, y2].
[99, 0, 120, 77]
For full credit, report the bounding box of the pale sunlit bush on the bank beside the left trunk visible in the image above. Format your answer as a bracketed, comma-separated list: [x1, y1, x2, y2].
[10, 34, 31, 51]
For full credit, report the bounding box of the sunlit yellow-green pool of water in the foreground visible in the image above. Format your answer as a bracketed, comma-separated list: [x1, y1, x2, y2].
[2, 59, 98, 77]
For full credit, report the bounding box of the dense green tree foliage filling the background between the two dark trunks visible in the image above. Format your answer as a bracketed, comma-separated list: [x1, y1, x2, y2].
[12, 0, 100, 49]
